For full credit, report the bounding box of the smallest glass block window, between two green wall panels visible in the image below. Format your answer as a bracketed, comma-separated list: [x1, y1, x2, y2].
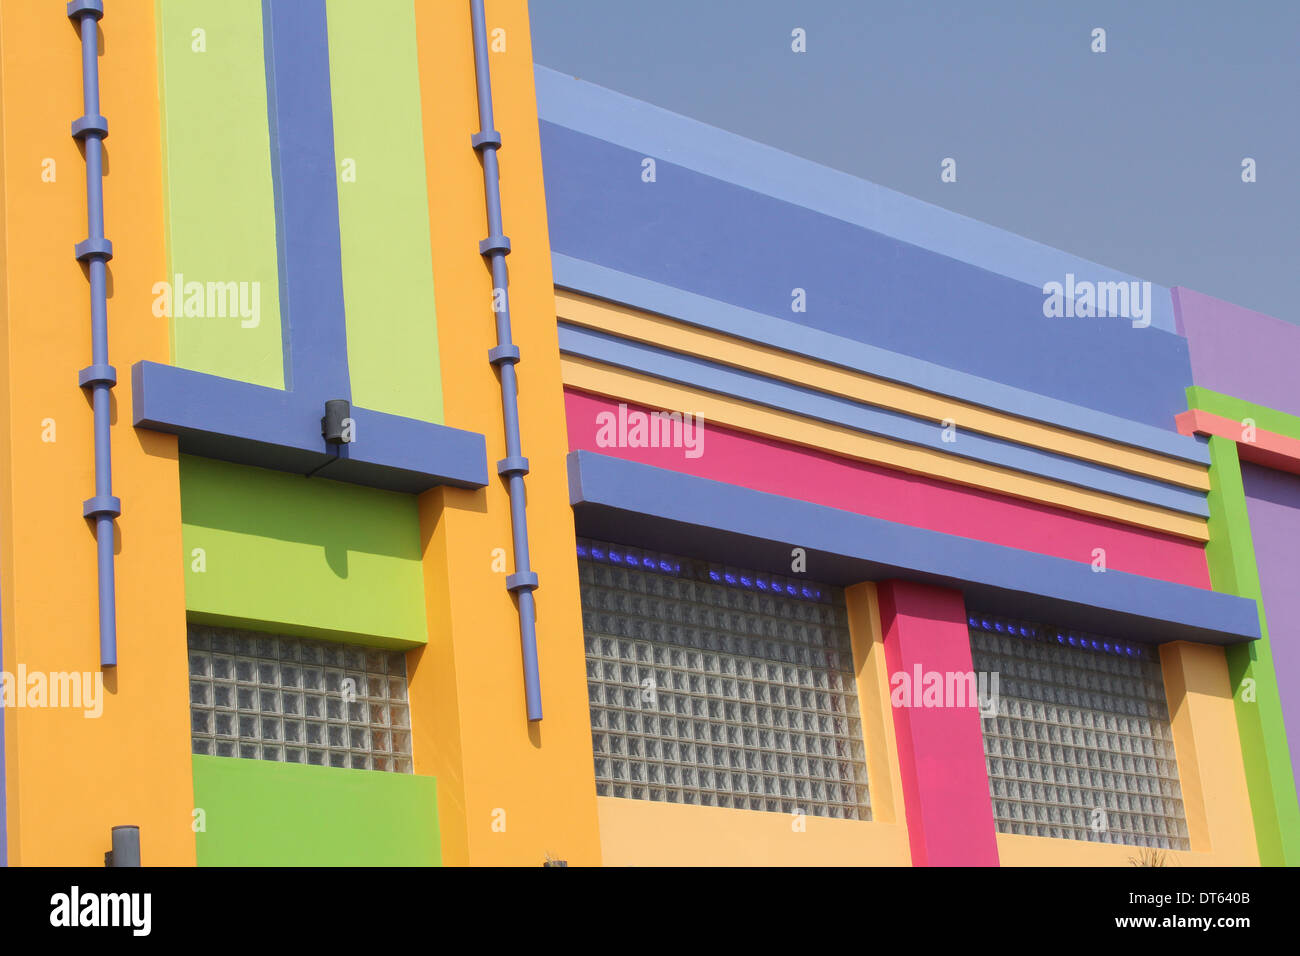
[189, 624, 412, 774]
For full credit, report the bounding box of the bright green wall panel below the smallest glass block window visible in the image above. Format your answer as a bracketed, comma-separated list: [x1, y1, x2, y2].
[194, 757, 442, 868]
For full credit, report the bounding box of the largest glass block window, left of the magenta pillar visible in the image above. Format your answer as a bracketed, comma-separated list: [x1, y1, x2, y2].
[579, 540, 871, 819]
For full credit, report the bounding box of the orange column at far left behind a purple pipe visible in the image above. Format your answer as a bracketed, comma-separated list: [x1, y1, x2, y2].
[0, 3, 194, 866]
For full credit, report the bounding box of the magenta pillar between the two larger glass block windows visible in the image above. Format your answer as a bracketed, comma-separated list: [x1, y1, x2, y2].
[878, 581, 997, 866]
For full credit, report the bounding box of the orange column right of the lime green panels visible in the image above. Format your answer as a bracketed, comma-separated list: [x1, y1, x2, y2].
[411, 0, 601, 866]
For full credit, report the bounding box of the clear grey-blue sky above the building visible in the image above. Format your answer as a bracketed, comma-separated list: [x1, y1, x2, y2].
[529, 0, 1300, 324]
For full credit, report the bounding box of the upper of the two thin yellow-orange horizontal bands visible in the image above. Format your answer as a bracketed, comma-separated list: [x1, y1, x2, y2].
[555, 289, 1210, 492]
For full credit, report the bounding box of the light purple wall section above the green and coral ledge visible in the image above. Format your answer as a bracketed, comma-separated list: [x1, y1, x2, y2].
[1173, 287, 1300, 415]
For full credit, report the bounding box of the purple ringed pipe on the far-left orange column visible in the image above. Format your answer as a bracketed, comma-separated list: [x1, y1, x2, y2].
[68, 0, 122, 667]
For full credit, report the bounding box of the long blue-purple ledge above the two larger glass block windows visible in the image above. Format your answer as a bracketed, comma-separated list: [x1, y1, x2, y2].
[568, 451, 1260, 644]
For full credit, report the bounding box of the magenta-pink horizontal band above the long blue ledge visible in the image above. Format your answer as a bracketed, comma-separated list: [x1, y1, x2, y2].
[564, 389, 1210, 588]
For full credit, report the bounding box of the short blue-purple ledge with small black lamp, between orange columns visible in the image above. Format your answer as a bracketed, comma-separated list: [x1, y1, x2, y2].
[131, 362, 488, 494]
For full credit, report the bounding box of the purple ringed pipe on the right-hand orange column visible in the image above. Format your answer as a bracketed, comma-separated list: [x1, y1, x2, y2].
[469, 0, 542, 721]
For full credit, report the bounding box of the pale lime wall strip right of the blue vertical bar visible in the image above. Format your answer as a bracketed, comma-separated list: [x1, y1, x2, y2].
[326, 0, 441, 423]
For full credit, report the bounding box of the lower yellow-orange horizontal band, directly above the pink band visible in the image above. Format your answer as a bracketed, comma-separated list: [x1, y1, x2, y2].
[560, 355, 1209, 541]
